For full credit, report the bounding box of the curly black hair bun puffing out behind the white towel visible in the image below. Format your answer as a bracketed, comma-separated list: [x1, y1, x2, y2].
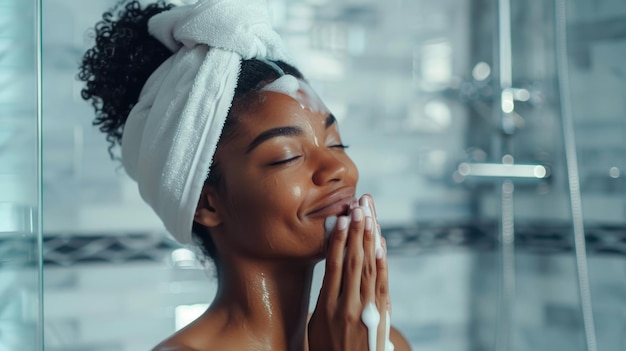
[78, 1, 174, 156]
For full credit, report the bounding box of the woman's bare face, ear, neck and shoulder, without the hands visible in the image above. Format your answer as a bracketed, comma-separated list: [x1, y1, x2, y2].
[155, 88, 412, 351]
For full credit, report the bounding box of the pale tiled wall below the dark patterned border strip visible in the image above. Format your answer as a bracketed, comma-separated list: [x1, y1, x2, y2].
[37, 250, 626, 351]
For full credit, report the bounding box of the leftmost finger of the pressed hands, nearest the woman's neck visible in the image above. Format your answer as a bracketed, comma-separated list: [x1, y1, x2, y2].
[320, 216, 350, 300]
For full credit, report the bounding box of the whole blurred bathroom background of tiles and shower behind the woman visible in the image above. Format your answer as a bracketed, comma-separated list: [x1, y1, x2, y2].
[0, 0, 626, 351]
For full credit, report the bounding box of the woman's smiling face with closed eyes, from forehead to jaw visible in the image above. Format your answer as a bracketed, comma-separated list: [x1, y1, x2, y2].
[211, 85, 358, 259]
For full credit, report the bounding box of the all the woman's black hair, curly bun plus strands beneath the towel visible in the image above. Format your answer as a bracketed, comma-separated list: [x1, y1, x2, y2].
[77, 0, 304, 271]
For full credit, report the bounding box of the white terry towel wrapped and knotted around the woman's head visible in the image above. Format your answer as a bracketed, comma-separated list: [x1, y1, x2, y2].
[122, 0, 291, 244]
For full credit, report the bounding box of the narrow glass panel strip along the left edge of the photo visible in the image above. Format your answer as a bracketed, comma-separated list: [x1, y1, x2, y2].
[0, 0, 42, 351]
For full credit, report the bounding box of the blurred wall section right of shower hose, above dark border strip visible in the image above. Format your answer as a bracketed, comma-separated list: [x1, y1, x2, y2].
[567, 0, 626, 226]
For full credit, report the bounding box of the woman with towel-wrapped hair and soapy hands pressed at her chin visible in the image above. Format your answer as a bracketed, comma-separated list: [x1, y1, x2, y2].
[79, 0, 409, 351]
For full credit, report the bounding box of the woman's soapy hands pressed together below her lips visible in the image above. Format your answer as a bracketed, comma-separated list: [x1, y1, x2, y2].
[308, 195, 391, 351]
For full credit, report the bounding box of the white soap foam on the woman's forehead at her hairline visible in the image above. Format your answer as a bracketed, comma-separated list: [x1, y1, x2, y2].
[261, 74, 328, 113]
